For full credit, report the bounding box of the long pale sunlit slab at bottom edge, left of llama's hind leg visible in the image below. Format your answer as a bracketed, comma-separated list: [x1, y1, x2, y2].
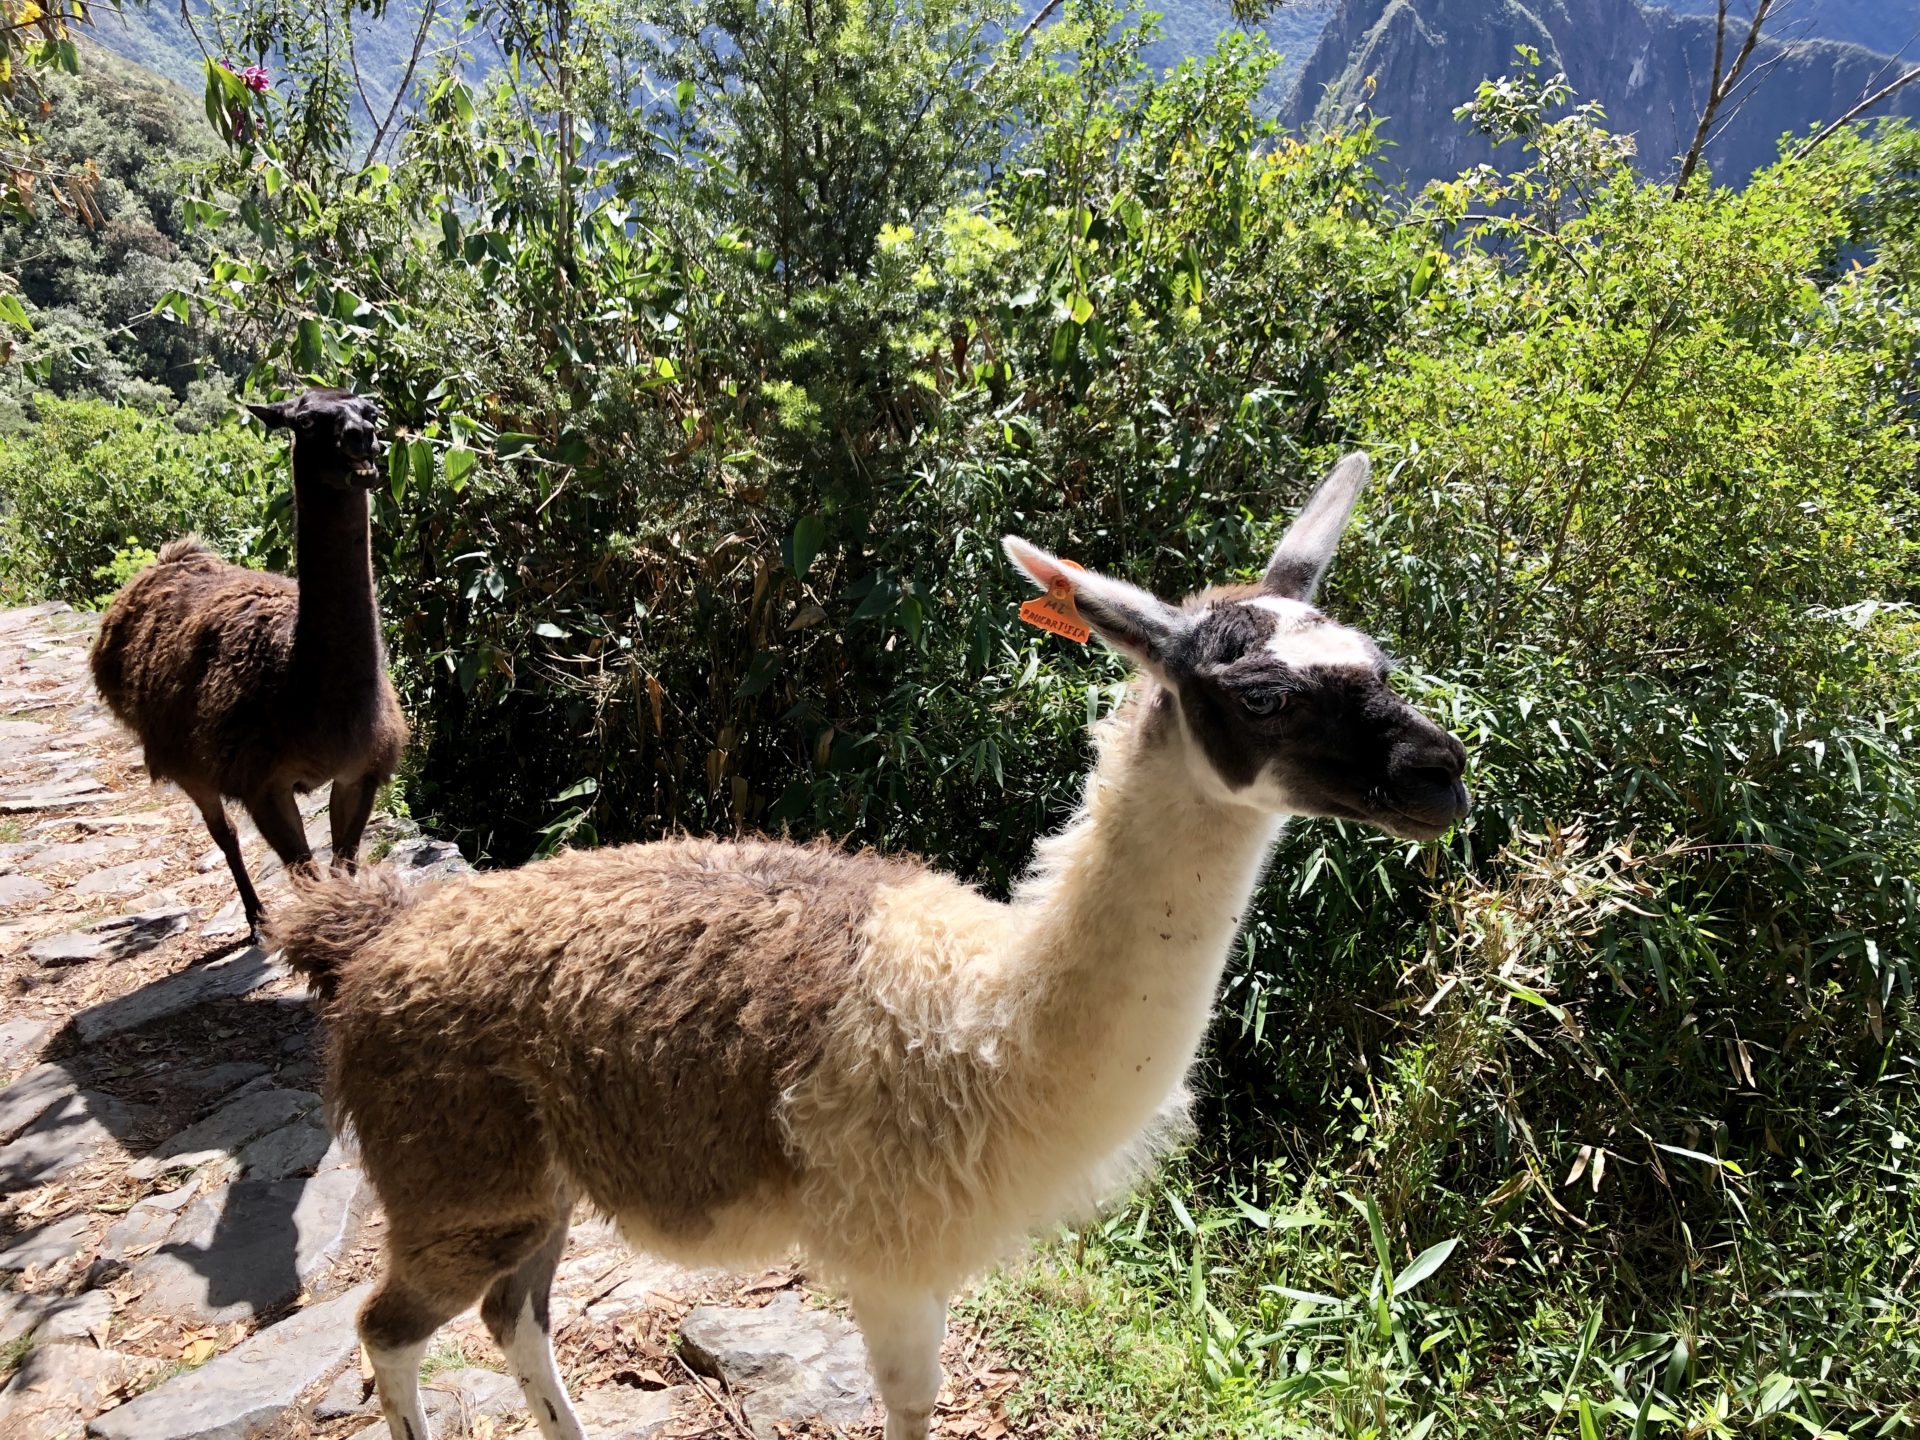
[86, 1284, 370, 1440]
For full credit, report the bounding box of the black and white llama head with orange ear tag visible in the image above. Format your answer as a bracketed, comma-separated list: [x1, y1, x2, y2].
[1004, 455, 1467, 839]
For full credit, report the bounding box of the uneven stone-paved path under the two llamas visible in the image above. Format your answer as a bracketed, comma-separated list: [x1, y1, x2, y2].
[0, 605, 1060, 1440]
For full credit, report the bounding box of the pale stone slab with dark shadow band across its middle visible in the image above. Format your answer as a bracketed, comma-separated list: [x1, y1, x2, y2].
[132, 1167, 361, 1323]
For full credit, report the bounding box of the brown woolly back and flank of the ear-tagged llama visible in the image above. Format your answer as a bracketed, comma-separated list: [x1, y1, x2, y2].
[275, 839, 922, 1254]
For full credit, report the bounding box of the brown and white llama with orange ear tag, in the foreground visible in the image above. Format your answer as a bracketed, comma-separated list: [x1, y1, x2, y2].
[276, 455, 1467, 1440]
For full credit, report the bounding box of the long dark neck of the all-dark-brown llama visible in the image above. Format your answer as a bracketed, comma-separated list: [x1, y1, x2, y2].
[294, 462, 380, 685]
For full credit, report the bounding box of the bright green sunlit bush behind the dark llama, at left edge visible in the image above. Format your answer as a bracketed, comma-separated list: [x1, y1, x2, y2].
[0, 396, 286, 605]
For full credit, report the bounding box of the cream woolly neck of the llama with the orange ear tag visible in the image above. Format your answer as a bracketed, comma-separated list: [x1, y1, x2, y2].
[1012, 698, 1281, 1154]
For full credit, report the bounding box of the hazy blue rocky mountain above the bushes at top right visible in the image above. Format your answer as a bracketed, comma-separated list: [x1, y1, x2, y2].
[1284, 0, 1920, 184]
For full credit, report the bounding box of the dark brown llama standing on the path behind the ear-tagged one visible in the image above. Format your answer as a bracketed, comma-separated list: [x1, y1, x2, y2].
[92, 390, 407, 939]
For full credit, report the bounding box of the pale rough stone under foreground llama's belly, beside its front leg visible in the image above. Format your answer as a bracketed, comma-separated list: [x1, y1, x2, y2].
[680, 1290, 874, 1440]
